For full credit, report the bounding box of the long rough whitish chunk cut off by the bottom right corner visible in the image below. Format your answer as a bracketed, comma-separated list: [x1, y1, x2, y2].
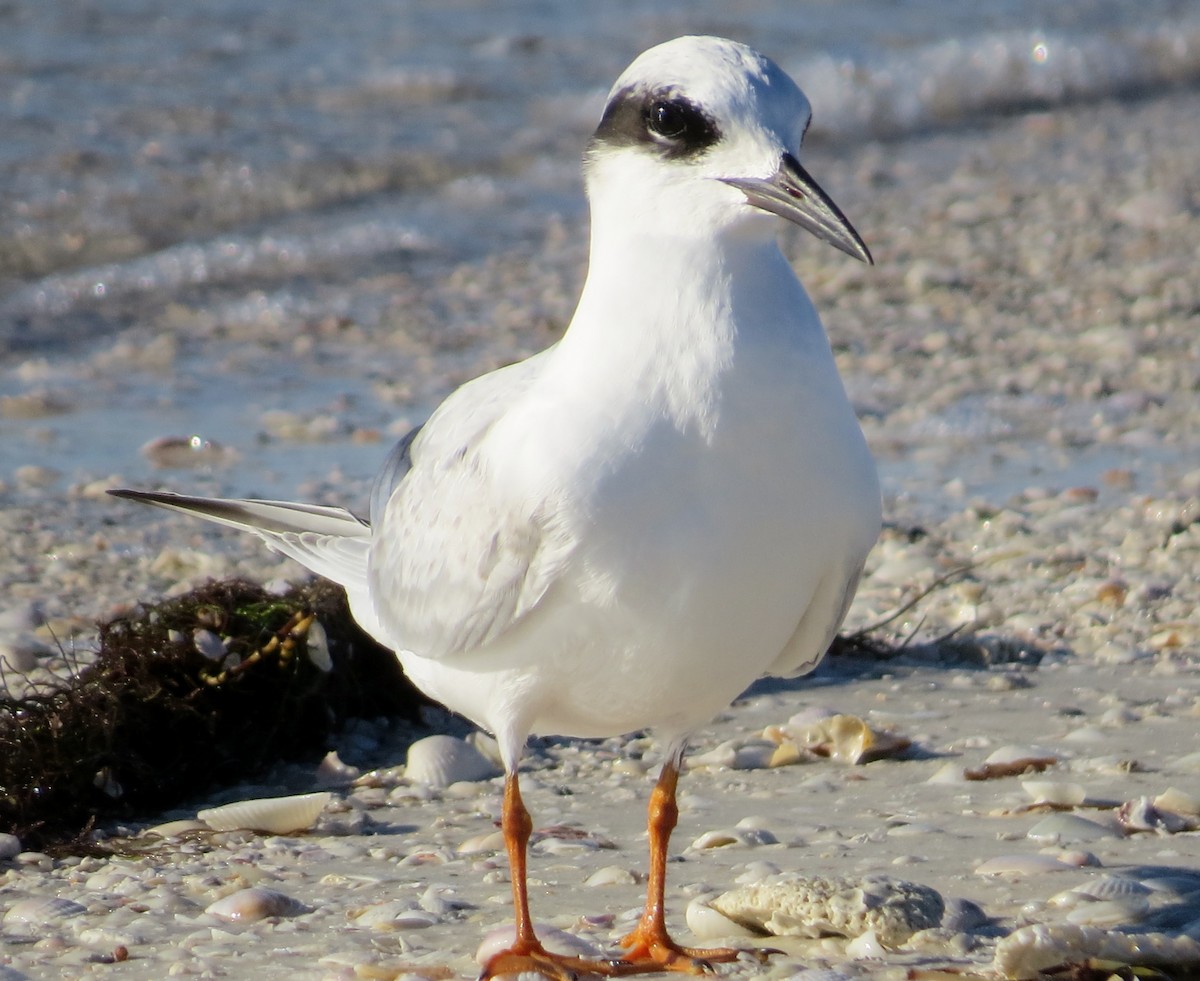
[992, 923, 1200, 979]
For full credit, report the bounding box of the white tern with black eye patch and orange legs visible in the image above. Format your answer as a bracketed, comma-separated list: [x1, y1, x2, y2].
[112, 37, 881, 977]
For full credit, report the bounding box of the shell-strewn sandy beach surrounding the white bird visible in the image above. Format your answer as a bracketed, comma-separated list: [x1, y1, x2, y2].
[0, 41, 1200, 981]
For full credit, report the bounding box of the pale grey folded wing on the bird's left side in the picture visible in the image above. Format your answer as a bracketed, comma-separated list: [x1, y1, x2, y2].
[371, 351, 575, 657]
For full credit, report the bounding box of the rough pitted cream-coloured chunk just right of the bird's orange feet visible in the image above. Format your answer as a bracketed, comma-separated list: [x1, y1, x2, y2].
[710, 875, 944, 946]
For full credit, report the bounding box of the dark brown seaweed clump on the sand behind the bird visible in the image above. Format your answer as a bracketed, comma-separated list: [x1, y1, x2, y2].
[0, 580, 422, 848]
